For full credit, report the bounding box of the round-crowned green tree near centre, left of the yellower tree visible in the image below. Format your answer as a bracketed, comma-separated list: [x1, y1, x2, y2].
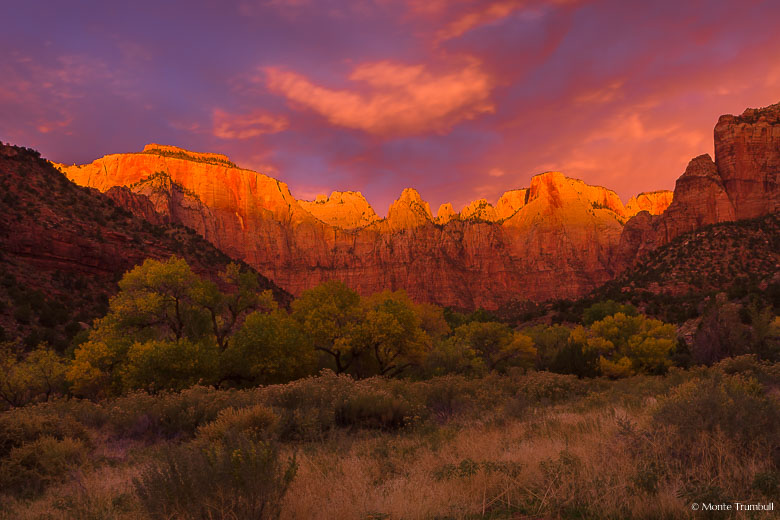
[292, 281, 364, 374]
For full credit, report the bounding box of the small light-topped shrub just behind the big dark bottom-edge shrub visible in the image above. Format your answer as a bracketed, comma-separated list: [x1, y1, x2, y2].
[197, 404, 279, 442]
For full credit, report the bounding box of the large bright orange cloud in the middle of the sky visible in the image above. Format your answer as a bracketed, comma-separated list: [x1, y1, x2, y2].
[265, 60, 495, 135]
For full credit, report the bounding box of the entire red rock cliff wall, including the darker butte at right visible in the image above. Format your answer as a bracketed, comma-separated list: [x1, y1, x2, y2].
[60, 105, 780, 308]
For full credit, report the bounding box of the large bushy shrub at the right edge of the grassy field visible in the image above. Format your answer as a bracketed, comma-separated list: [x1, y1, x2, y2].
[653, 372, 780, 449]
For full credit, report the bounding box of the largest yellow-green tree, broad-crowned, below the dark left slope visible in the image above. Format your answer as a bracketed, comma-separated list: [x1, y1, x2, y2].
[67, 257, 276, 396]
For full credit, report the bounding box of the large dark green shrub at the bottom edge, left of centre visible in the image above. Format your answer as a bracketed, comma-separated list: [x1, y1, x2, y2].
[135, 435, 297, 520]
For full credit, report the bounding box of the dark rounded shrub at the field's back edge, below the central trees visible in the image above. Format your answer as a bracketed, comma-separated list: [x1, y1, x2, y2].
[335, 385, 415, 430]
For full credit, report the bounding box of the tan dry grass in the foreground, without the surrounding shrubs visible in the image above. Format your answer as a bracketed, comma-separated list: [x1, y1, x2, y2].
[0, 362, 779, 520]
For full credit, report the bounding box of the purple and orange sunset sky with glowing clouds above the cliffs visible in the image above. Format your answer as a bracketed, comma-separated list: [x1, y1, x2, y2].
[0, 0, 780, 215]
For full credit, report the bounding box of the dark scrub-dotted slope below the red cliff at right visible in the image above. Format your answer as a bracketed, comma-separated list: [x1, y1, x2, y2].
[506, 213, 780, 323]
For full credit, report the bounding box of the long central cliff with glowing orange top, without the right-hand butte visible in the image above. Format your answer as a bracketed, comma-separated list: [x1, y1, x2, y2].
[61, 146, 622, 308]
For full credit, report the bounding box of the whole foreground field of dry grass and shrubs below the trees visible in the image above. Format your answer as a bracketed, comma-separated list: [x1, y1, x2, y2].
[0, 356, 780, 520]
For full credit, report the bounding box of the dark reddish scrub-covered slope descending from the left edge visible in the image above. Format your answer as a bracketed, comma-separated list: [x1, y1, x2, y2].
[0, 143, 289, 349]
